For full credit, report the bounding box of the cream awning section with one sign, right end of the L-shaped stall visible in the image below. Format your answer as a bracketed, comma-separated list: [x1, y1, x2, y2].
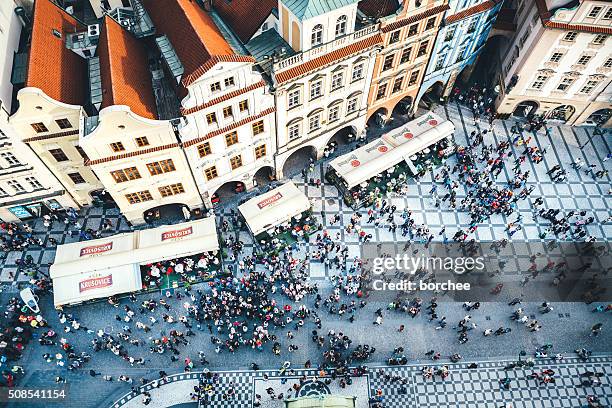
[135, 217, 219, 264]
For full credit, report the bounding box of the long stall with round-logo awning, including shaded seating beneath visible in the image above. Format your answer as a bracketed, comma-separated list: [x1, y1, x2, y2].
[326, 112, 455, 208]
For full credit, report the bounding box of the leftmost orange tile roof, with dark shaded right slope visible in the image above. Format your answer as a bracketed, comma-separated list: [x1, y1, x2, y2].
[26, 0, 87, 105]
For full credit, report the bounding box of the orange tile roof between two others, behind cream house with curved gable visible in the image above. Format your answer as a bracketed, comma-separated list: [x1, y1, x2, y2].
[98, 16, 157, 119]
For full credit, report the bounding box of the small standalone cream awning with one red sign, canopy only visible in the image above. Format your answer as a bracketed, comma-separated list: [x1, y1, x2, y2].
[238, 182, 310, 235]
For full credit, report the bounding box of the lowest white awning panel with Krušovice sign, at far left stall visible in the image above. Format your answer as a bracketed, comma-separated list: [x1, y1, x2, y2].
[53, 264, 142, 307]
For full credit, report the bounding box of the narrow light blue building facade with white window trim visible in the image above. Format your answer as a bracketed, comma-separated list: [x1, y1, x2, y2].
[417, 0, 503, 103]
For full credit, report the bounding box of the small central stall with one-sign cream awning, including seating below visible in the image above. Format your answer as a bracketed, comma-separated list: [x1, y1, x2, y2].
[238, 182, 318, 249]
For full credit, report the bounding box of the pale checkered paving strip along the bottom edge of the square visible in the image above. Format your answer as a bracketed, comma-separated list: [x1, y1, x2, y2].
[107, 355, 612, 408]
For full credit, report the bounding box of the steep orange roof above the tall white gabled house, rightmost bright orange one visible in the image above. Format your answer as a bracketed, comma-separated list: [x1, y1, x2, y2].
[143, 0, 235, 84]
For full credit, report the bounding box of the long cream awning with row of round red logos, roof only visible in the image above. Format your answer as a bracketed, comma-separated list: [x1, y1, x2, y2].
[330, 112, 455, 189]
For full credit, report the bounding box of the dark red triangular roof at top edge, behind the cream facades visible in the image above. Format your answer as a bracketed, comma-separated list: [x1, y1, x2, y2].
[213, 0, 278, 43]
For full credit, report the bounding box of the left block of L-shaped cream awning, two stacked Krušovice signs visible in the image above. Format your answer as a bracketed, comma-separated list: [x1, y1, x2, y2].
[49, 233, 142, 307]
